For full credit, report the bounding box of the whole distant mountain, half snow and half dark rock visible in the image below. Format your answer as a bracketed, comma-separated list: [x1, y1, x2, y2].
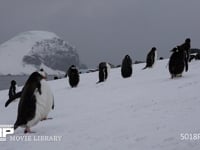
[0, 31, 86, 75]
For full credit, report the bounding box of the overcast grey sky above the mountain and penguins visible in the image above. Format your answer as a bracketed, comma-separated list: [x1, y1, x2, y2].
[0, 0, 200, 66]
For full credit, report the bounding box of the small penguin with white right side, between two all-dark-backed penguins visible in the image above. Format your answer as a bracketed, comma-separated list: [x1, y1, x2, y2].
[97, 62, 110, 83]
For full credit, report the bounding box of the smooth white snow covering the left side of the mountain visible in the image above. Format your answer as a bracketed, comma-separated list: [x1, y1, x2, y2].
[0, 31, 57, 74]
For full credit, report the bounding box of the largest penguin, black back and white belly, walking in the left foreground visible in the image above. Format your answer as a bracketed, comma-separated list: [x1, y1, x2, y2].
[5, 72, 54, 133]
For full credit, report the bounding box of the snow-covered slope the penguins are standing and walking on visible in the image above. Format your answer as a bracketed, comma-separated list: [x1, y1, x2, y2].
[0, 60, 200, 150]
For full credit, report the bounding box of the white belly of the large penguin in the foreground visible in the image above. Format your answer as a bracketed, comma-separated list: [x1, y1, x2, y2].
[27, 79, 53, 127]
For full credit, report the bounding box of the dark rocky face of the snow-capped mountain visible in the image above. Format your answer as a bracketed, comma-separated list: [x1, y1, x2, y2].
[23, 37, 80, 72]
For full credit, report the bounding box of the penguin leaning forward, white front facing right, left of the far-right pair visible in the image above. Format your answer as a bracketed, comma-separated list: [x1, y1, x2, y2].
[143, 47, 157, 69]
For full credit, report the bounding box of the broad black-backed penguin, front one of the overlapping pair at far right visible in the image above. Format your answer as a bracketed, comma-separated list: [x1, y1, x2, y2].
[169, 46, 187, 79]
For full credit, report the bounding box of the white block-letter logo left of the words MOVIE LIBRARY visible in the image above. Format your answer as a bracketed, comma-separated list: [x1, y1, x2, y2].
[0, 125, 14, 141]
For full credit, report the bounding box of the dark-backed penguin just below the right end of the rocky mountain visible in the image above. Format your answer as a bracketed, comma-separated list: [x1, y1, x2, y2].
[67, 65, 79, 88]
